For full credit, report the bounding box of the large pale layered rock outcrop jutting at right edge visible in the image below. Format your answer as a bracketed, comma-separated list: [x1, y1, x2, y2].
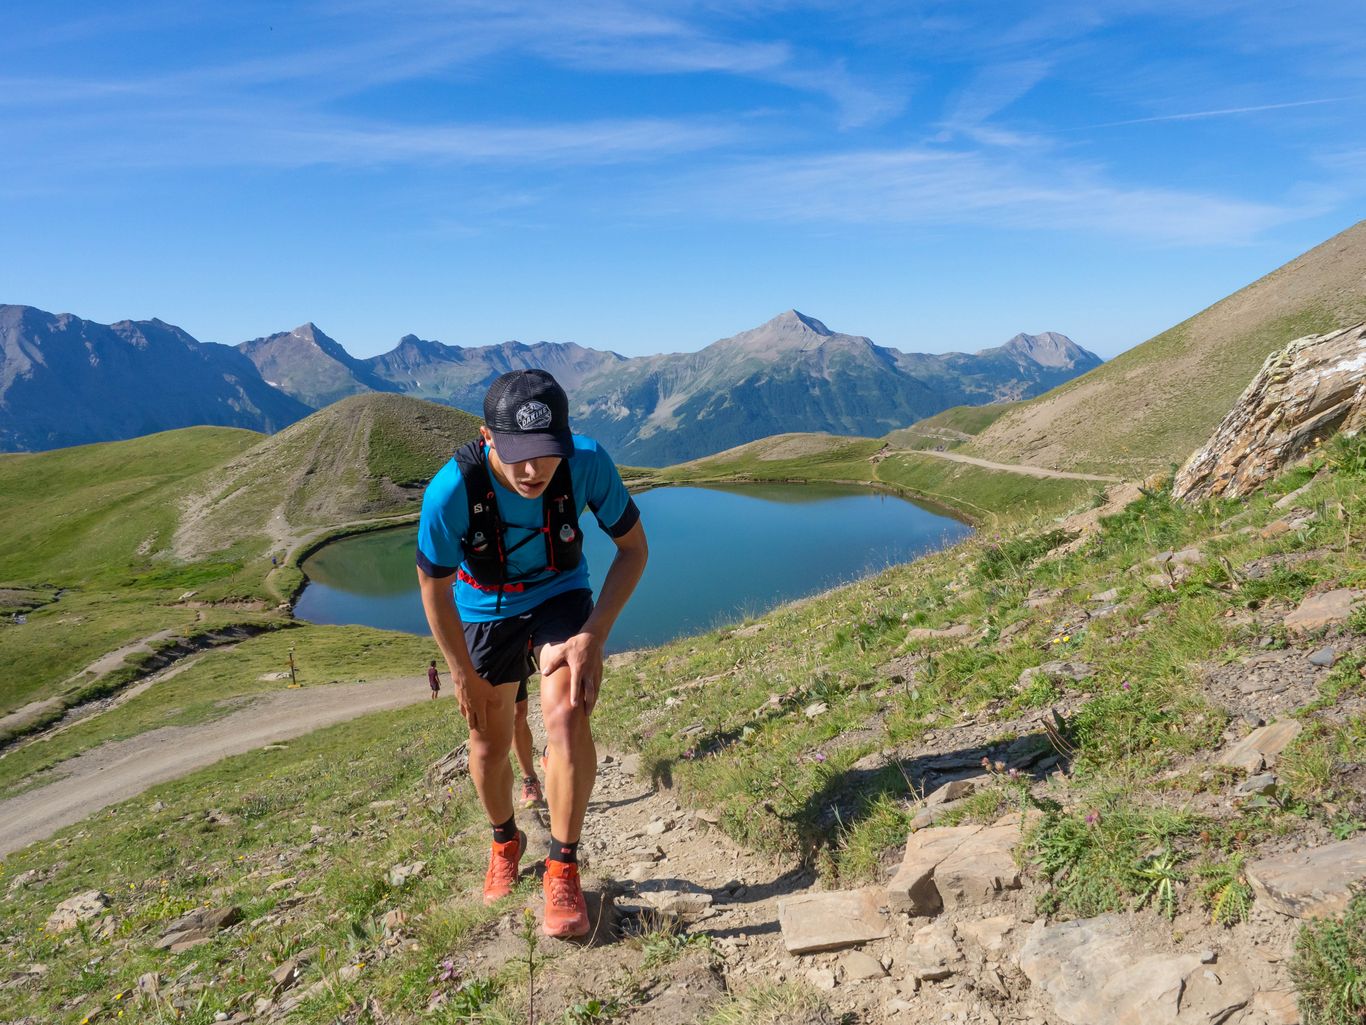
[1172, 324, 1366, 500]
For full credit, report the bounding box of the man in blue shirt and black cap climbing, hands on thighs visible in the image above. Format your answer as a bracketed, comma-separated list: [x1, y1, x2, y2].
[417, 370, 647, 936]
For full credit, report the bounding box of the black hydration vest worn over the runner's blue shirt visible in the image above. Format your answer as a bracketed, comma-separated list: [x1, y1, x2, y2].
[455, 439, 583, 610]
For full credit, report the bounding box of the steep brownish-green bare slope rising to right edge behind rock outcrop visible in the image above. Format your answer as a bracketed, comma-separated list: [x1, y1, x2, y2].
[964, 221, 1366, 477]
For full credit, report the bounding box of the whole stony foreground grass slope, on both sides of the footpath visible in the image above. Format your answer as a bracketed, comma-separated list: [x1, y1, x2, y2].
[0, 440, 1366, 1025]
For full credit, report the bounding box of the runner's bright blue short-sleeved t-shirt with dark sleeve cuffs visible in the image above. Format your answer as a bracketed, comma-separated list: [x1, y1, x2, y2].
[418, 435, 641, 623]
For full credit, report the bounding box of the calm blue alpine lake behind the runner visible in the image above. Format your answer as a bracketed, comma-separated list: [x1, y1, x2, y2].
[294, 484, 971, 652]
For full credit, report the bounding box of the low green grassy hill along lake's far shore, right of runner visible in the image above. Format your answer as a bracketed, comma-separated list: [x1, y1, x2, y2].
[649, 431, 1097, 523]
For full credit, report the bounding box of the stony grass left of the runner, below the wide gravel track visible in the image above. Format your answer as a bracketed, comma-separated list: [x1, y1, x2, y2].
[0, 704, 500, 1024]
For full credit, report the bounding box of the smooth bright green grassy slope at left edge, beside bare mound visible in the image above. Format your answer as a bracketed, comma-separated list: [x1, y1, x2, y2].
[0, 428, 274, 715]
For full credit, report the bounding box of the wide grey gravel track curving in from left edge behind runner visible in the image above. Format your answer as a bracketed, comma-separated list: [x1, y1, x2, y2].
[0, 677, 430, 856]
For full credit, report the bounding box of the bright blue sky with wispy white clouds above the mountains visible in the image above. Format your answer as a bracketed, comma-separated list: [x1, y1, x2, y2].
[0, 0, 1366, 357]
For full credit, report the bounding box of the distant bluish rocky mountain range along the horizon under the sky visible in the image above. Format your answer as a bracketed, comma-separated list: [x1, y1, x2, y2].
[0, 306, 1101, 466]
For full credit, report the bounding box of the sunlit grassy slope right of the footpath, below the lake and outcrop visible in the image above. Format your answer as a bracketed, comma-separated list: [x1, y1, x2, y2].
[598, 440, 1366, 891]
